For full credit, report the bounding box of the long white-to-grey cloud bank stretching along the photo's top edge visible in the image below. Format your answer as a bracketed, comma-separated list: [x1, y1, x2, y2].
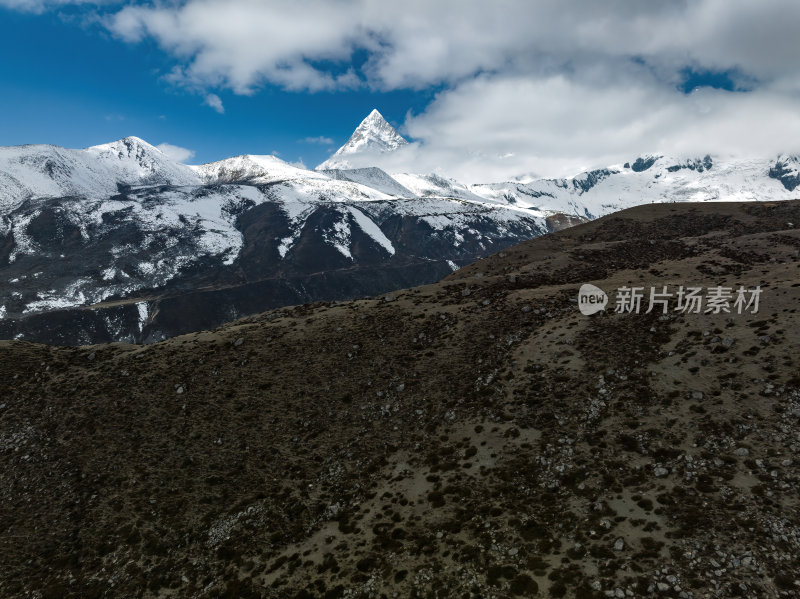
[101, 0, 800, 93]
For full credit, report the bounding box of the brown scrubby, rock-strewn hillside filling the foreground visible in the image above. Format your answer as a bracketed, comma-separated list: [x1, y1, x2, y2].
[0, 201, 800, 598]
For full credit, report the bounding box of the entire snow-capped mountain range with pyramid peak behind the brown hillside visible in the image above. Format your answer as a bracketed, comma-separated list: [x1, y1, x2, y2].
[0, 111, 800, 345]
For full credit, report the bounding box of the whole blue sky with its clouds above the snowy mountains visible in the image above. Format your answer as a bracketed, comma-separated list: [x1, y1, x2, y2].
[0, 0, 800, 181]
